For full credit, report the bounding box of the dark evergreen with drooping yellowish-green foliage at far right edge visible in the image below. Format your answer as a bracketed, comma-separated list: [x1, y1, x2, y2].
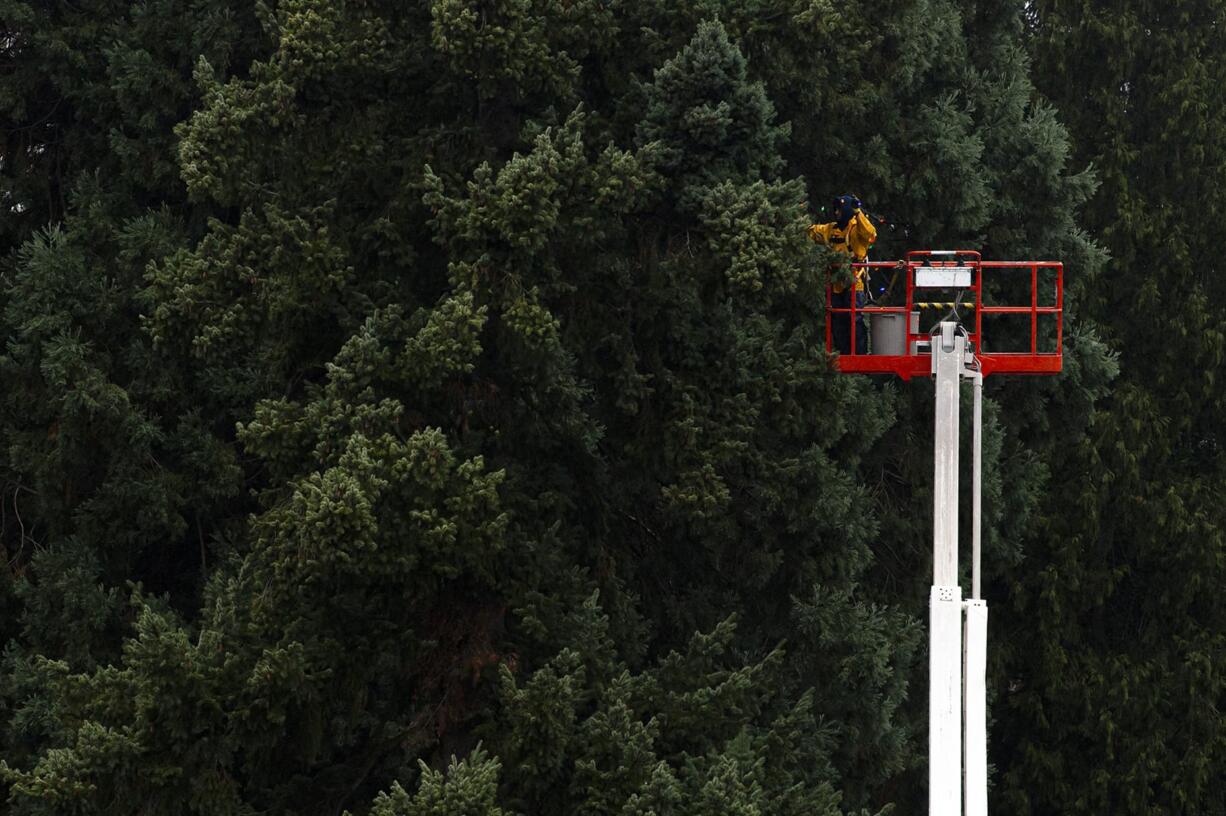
[997, 1, 1226, 814]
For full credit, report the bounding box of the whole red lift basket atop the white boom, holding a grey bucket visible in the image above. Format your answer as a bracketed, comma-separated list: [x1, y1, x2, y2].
[826, 250, 1064, 380]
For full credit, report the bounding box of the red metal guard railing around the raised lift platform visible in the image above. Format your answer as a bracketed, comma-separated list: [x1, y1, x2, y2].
[826, 250, 1064, 380]
